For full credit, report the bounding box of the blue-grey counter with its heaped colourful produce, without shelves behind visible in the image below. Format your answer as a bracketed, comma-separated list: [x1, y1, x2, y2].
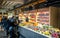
[19, 23, 60, 38]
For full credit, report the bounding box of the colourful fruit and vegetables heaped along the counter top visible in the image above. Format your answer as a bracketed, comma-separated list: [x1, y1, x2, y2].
[19, 22, 60, 38]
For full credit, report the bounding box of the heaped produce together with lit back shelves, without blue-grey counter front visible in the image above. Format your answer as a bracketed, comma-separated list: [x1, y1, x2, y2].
[19, 8, 60, 38]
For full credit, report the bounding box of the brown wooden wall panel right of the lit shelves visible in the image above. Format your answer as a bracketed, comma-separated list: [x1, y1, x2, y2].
[49, 6, 60, 29]
